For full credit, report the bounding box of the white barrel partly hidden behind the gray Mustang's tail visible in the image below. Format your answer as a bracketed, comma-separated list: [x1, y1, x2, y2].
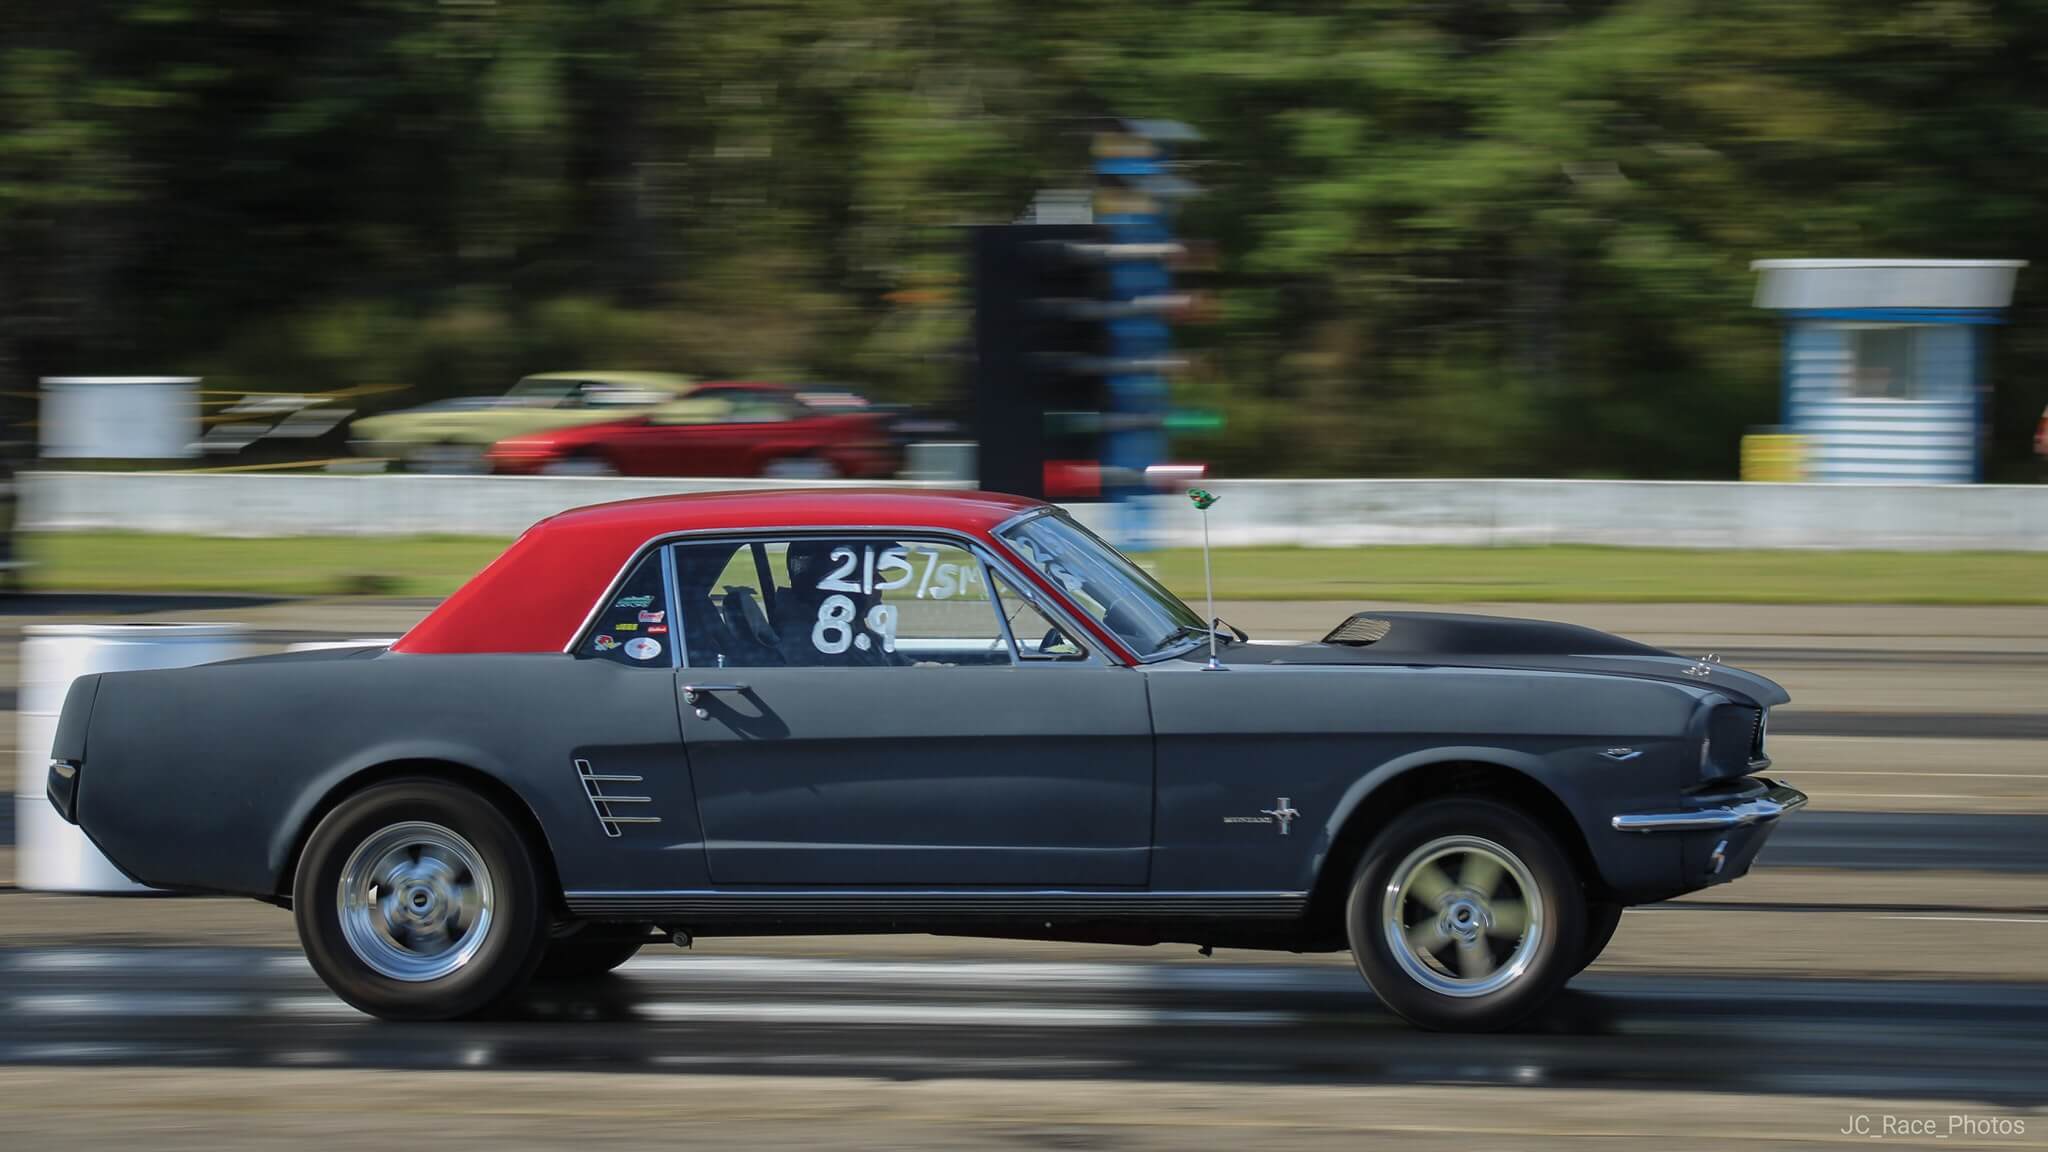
[14, 623, 252, 892]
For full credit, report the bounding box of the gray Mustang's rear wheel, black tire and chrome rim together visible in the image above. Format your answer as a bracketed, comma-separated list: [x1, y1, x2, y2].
[291, 779, 547, 1021]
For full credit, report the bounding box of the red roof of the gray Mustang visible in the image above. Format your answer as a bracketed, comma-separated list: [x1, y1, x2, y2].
[391, 488, 1042, 654]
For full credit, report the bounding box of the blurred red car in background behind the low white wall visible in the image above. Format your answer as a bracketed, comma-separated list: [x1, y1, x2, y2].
[489, 381, 899, 480]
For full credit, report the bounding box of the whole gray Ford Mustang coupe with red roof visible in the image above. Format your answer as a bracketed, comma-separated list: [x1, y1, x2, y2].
[49, 490, 1806, 1029]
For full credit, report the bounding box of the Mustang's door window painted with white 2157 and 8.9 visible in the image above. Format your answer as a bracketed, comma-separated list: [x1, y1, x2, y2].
[674, 535, 1012, 668]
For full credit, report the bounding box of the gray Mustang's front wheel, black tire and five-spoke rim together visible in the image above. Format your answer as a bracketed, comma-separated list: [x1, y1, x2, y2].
[1346, 799, 1587, 1031]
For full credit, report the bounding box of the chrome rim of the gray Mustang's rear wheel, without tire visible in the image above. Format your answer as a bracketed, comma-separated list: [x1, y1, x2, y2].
[336, 822, 492, 982]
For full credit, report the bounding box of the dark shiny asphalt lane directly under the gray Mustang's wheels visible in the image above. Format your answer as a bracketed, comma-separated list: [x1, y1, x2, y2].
[0, 947, 2048, 1105]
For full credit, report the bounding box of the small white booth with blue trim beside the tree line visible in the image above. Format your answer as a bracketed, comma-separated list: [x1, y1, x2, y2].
[1751, 260, 2025, 484]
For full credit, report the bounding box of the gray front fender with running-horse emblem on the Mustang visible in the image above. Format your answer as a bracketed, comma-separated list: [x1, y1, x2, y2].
[1145, 664, 1704, 898]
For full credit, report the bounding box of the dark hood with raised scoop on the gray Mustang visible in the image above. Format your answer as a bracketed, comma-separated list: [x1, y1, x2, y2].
[1202, 611, 1792, 707]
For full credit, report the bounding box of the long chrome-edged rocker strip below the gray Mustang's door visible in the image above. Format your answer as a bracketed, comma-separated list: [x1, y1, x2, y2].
[563, 888, 1309, 922]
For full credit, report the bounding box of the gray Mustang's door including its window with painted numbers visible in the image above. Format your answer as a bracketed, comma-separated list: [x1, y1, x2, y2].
[674, 533, 1153, 888]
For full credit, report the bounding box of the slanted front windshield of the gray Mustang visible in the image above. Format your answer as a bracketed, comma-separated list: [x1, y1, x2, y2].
[1001, 515, 1204, 656]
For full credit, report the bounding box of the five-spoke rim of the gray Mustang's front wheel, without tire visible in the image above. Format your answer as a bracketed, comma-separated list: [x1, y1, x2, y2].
[1382, 836, 1544, 996]
